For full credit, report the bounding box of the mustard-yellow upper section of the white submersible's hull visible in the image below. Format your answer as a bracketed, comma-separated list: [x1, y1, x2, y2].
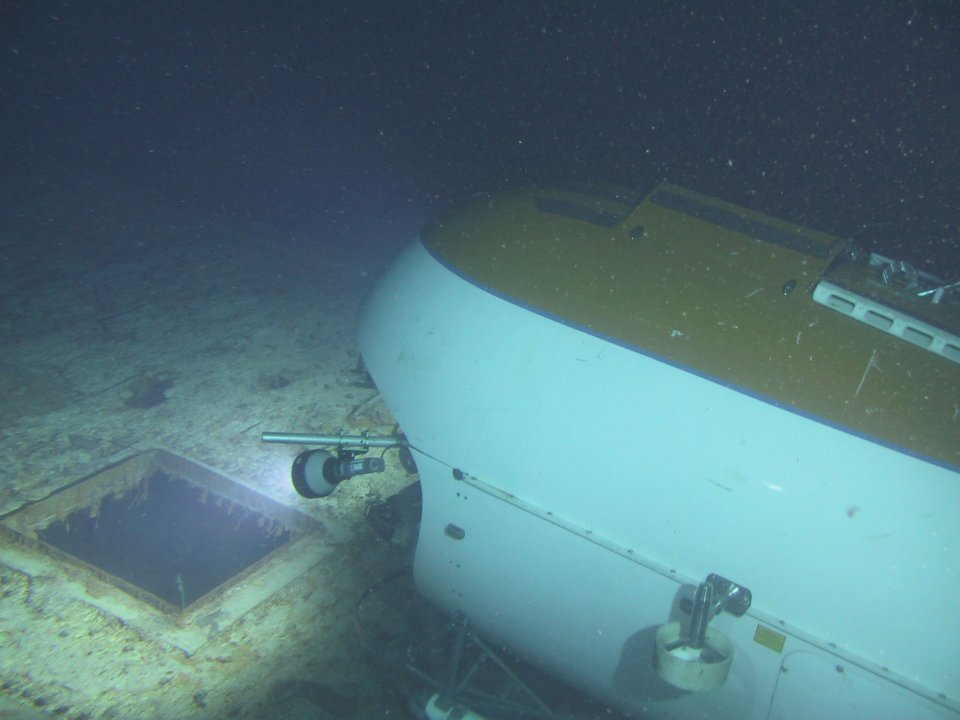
[424, 184, 960, 468]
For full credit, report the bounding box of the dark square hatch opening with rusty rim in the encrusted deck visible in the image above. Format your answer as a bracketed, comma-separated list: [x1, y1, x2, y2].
[2, 450, 316, 614]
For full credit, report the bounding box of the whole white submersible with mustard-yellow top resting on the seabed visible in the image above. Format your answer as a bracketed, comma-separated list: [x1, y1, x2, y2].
[360, 185, 960, 720]
